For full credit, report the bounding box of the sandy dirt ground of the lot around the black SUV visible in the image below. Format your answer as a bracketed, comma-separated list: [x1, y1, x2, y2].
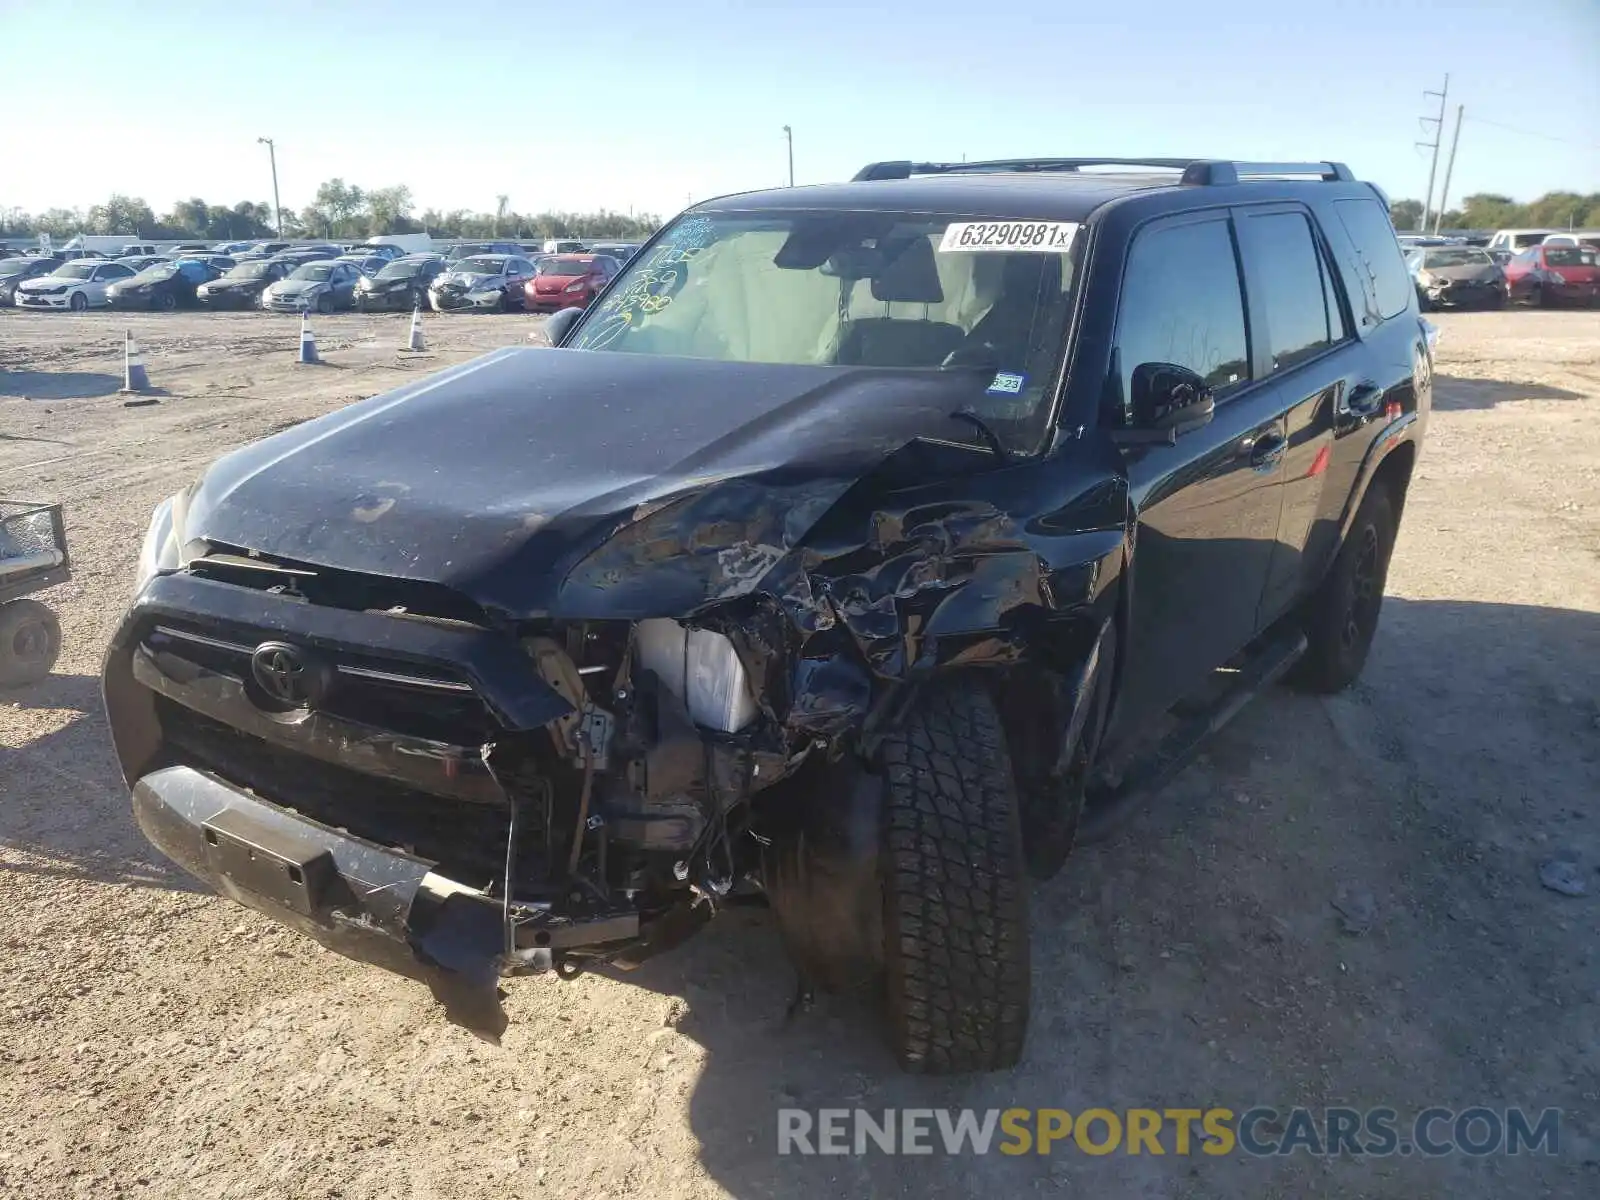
[0, 310, 1600, 1200]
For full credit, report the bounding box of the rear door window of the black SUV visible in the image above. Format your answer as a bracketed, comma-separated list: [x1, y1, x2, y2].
[1242, 213, 1342, 371]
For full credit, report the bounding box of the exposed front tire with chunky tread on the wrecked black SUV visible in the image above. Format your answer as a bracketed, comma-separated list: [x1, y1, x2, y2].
[882, 677, 1029, 1075]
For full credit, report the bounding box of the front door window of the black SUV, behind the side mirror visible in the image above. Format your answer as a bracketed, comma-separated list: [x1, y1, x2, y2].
[1117, 219, 1250, 403]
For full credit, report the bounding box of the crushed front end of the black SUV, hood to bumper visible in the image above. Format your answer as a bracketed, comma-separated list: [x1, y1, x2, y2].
[104, 342, 1126, 1034]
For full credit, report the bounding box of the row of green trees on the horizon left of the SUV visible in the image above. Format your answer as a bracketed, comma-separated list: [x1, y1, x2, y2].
[0, 179, 661, 242]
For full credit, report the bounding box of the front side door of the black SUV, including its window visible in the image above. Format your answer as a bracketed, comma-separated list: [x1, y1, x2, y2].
[1115, 211, 1286, 720]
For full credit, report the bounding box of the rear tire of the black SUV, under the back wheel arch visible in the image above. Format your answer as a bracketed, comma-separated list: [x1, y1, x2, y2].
[1293, 483, 1395, 693]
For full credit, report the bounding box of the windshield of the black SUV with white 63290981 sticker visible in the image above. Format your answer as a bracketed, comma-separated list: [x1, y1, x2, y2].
[568, 211, 1077, 440]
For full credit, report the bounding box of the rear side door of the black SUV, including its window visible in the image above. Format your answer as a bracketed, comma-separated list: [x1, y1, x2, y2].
[1234, 205, 1381, 627]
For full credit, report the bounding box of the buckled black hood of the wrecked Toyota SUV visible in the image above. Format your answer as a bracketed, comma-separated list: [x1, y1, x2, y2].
[186, 349, 995, 618]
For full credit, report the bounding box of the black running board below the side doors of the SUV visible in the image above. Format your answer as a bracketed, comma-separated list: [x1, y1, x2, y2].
[1077, 629, 1306, 843]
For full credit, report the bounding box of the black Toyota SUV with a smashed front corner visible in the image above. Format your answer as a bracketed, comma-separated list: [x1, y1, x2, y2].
[104, 158, 1432, 1072]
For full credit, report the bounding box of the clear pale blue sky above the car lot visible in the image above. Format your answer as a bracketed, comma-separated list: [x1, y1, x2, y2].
[0, 0, 1600, 213]
